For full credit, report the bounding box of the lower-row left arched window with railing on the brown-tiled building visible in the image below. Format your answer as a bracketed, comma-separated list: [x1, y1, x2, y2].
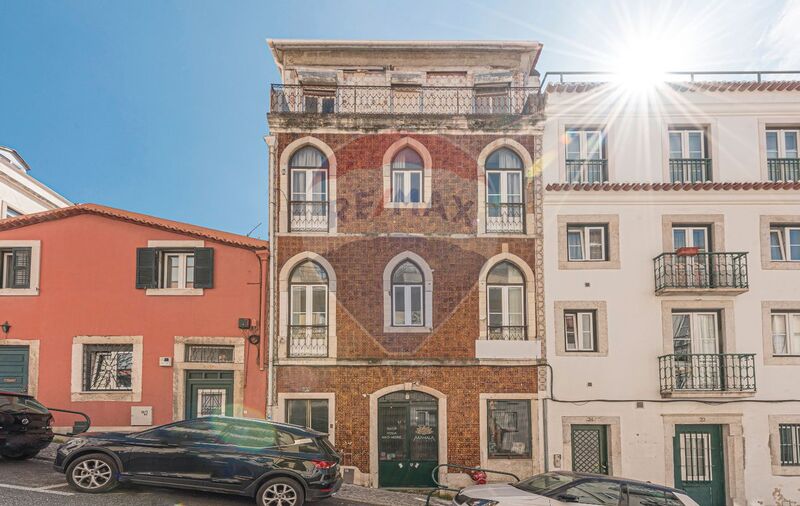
[288, 260, 328, 357]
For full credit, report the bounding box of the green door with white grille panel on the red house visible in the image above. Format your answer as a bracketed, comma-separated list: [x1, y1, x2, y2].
[184, 371, 233, 418]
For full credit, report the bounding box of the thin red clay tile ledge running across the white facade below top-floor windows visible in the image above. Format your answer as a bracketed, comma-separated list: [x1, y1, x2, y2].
[545, 181, 800, 192]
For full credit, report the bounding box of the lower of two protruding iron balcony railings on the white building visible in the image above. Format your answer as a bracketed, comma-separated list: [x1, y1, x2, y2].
[658, 353, 756, 394]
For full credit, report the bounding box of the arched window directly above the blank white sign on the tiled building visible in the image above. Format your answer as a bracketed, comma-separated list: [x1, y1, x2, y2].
[486, 262, 527, 340]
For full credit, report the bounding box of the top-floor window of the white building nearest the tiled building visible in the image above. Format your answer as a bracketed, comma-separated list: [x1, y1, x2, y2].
[566, 128, 608, 183]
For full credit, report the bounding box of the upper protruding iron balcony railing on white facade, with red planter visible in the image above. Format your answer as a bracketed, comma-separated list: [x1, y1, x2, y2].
[653, 250, 748, 294]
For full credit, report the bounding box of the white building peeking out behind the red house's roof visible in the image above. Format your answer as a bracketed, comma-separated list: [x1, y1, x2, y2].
[0, 146, 72, 219]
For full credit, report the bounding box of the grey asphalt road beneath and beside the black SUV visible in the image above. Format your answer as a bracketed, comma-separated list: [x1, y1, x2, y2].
[0, 458, 365, 506]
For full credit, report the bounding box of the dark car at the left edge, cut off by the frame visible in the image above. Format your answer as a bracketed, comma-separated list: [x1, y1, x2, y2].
[0, 391, 53, 460]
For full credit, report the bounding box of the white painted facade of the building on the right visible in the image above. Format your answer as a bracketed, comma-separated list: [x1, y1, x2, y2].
[540, 85, 800, 505]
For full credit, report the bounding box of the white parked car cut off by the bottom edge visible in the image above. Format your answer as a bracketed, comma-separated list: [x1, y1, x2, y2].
[453, 472, 698, 506]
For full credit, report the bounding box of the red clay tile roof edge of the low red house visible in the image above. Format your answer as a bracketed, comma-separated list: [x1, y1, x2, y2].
[0, 204, 269, 249]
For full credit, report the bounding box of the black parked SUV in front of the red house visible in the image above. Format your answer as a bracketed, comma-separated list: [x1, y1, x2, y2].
[53, 416, 342, 506]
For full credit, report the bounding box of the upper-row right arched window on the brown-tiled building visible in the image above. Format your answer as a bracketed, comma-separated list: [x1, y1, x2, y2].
[485, 148, 525, 233]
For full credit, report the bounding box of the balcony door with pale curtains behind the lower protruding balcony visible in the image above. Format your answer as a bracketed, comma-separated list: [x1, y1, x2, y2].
[672, 312, 722, 390]
